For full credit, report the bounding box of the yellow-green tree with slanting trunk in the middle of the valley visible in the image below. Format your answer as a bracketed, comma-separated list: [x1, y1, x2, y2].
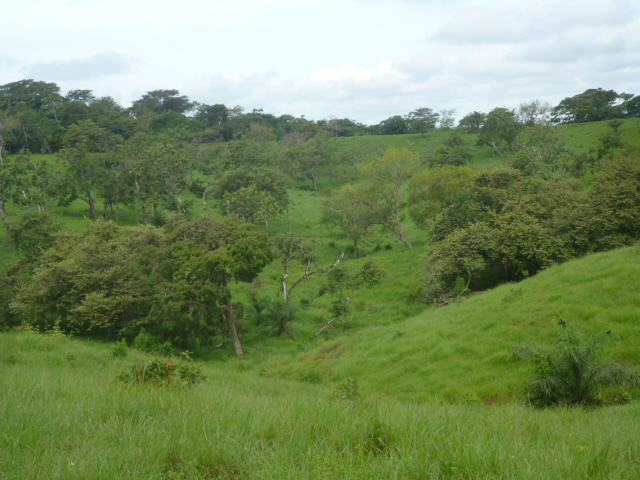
[354, 148, 418, 248]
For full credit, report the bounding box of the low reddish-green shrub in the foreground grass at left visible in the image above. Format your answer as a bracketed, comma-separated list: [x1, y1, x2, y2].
[118, 358, 204, 386]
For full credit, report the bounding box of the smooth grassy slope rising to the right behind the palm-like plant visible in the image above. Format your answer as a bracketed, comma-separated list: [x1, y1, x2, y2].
[248, 247, 640, 403]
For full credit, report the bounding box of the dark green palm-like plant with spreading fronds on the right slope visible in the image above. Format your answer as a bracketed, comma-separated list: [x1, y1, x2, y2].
[513, 320, 640, 407]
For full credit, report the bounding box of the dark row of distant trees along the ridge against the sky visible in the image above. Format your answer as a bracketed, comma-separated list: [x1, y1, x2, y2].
[0, 79, 640, 158]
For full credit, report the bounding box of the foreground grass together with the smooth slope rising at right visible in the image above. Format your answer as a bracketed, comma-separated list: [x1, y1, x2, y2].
[0, 247, 640, 480]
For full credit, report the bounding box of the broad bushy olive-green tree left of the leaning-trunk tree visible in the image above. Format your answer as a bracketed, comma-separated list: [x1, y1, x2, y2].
[10, 218, 162, 336]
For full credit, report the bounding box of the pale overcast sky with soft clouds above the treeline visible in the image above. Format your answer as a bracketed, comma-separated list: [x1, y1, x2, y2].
[0, 0, 640, 125]
